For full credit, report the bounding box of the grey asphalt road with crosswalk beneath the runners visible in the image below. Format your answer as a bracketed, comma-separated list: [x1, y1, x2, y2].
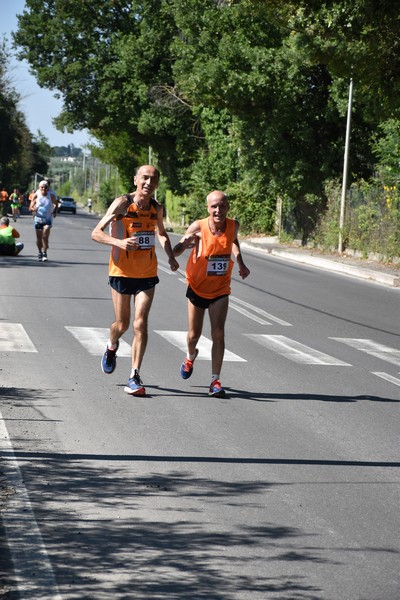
[0, 209, 400, 600]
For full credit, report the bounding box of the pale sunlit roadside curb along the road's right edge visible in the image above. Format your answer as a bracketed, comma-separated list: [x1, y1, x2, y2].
[240, 240, 400, 287]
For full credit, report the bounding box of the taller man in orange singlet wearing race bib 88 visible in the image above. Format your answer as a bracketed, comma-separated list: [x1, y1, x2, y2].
[92, 165, 179, 396]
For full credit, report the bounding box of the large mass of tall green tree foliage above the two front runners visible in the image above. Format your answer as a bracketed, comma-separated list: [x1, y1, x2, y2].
[10, 0, 400, 246]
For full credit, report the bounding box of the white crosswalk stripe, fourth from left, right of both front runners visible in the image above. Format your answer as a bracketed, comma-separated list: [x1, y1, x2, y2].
[244, 333, 351, 367]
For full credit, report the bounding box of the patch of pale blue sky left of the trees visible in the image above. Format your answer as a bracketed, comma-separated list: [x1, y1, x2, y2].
[0, 0, 91, 148]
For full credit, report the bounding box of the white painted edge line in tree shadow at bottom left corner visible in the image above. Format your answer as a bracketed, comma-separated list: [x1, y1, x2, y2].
[0, 413, 62, 600]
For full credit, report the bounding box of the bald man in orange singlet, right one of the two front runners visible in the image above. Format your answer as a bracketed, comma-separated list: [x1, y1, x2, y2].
[173, 190, 250, 398]
